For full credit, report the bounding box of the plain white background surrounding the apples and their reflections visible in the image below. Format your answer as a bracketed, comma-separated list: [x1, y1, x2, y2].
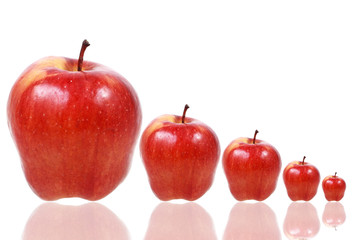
[0, 0, 360, 239]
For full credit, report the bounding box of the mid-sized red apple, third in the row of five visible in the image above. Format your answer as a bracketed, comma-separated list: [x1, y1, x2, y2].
[222, 130, 281, 201]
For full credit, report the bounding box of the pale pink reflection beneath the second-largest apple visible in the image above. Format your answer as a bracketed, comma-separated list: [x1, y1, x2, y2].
[144, 202, 217, 240]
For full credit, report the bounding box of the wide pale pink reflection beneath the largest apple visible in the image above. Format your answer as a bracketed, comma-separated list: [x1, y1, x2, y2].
[23, 203, 130, 240]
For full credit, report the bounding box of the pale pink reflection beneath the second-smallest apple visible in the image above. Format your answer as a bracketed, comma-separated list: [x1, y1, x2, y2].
[284, 202, 320, 239]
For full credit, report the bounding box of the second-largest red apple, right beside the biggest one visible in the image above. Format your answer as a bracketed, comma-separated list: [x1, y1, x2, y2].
[140, 105, 220, 201]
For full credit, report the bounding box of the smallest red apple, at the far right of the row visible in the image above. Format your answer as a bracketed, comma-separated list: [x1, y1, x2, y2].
[322, 172, 346, 201]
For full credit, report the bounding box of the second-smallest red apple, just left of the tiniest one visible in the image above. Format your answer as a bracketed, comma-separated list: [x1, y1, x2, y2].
[283, 157, 320, 201]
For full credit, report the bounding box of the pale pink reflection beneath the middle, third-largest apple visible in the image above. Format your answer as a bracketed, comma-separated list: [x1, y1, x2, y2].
[223, 202, 281, 240]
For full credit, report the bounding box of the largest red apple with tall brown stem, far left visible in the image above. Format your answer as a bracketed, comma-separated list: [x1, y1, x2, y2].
[7, 40, 141, 200]
